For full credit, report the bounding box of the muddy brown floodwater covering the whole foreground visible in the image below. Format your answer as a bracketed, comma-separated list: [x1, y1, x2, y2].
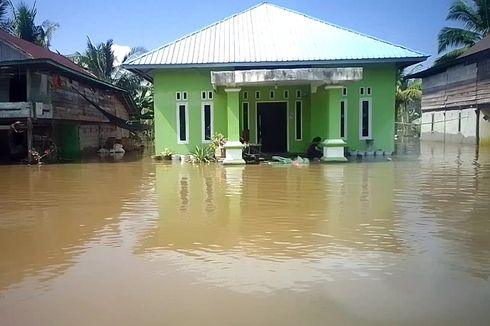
[0, 144, 490, 326]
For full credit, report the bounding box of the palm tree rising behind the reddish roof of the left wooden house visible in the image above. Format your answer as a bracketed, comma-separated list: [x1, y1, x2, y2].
[8, 1, 59, 48]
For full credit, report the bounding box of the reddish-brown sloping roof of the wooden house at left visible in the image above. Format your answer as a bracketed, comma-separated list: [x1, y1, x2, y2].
[0, 29, 93, 77]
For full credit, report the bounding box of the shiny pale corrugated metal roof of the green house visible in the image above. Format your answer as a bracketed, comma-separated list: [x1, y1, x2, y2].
[125, 3, 426, 68]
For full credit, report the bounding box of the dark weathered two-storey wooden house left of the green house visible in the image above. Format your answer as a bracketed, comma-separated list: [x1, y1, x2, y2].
[0, 29, 141, 162]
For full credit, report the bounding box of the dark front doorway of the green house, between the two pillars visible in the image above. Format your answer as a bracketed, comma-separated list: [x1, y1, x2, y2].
[257, 102, 288, 153]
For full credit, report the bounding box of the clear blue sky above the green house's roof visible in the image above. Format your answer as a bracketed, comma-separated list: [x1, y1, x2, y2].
[31, 0, 452, 67]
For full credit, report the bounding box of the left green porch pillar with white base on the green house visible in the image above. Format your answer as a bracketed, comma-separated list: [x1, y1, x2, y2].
[223, 88, 245, 164]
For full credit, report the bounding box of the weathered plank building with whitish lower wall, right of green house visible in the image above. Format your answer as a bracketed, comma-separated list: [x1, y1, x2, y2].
[411, 36, 490, 144]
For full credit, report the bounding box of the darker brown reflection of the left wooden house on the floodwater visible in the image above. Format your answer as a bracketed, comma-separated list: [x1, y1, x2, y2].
[0, 164, 151, 290]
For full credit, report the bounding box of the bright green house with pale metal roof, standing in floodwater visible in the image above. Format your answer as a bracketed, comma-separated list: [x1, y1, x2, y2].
[125, 3, 426, 163]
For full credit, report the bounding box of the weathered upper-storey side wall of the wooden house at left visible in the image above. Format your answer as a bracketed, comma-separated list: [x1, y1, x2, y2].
[50, 75, 129, 122]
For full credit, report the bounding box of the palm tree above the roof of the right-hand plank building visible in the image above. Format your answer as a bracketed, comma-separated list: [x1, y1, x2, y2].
[436, 0, 490, 64]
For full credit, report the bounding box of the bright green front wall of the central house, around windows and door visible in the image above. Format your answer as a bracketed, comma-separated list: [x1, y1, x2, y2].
[154, 65, 396, 154]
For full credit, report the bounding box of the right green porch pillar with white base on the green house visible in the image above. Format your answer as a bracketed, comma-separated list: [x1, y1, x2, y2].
[322, 87, 347, 162]
